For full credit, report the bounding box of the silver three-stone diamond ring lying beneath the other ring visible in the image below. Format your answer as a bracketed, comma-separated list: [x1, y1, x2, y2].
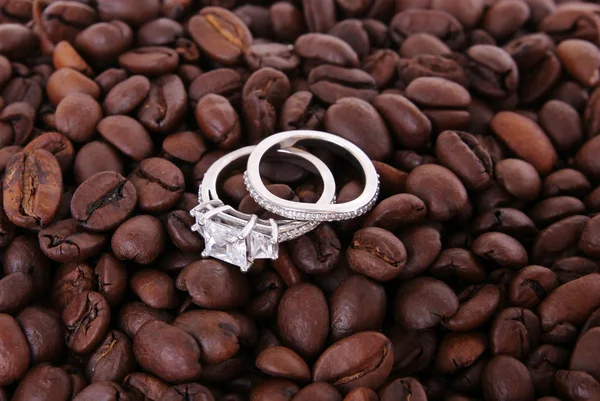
[190, 146, 336, 271]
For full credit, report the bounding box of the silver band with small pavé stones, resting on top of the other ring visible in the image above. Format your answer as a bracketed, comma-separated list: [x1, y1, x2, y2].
[244, 130, 379, 222]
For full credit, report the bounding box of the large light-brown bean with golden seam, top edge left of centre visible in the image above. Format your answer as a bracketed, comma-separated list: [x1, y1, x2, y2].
[188, 7, 252, 65]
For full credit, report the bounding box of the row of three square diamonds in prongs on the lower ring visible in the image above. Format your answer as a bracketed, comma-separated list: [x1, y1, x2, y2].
[191, 210, 279, 272]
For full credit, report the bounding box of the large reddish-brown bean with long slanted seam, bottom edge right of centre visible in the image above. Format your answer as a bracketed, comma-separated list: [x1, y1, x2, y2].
[313, 331, 394, 393]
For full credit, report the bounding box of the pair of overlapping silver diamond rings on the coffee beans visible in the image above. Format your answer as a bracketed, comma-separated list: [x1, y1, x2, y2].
[190, 130, 379, 272]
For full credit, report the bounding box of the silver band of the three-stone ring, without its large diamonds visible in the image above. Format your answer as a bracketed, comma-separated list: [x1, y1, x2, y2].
[198, 146, 336, 242]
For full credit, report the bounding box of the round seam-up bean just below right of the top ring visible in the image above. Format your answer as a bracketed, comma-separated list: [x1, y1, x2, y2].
[346, 227, 407, 281]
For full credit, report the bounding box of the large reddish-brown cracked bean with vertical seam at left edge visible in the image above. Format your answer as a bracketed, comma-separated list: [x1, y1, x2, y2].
[3, 149, 63, 228]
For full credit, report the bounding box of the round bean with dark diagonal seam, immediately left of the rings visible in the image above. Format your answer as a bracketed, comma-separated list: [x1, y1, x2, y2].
[128, 157, 185, 212]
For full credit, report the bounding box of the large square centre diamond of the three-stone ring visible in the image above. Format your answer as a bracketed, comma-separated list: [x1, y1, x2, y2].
[200, 220, 249, 269]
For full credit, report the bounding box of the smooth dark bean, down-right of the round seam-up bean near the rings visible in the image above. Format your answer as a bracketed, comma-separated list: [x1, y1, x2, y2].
[394, 277, 458, 330]
